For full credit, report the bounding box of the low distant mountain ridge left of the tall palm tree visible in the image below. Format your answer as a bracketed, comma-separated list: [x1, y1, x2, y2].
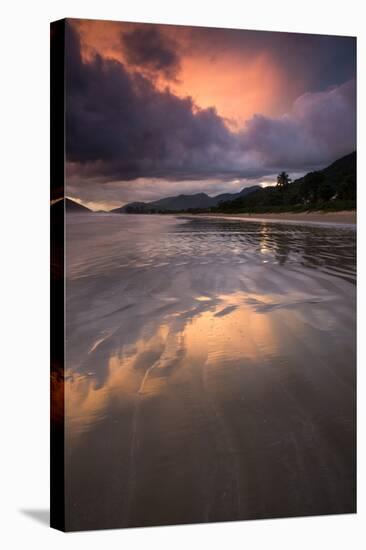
[111, 185, 261, 214]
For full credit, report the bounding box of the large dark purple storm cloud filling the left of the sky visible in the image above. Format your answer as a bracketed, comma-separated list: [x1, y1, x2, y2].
[66, 23, 243, 179]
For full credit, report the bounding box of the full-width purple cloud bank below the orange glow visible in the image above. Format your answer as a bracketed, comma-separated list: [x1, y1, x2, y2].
[66, 22, 355, 188]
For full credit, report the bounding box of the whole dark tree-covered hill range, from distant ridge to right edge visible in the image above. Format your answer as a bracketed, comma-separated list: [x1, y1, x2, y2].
[118, 152, 356, 218]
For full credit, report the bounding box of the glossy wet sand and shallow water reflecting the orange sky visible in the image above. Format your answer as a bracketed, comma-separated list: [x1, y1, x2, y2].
[65, 214, 356, 530]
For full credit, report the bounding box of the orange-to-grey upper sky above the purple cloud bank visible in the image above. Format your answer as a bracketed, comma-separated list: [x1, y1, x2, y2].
[72, 20, 356, 127]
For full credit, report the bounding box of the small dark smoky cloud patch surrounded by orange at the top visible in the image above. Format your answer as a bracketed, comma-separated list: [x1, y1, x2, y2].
[121, 25, 180, 79]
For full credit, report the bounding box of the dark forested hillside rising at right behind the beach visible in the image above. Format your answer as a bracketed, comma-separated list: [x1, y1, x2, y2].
[213, 151, 357, 213]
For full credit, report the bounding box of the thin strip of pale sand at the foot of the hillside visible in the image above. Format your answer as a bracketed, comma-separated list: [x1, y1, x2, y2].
[178, 210, 357, 227]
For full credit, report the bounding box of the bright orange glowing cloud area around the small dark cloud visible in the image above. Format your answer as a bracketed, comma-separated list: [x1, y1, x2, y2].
[72, 20, 298, 129]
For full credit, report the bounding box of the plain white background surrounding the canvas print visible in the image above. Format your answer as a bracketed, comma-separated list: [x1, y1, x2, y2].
[0, 0, 366, 550]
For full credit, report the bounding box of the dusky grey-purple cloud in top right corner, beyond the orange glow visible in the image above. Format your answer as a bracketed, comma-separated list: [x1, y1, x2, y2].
[184, 27, 356, 94]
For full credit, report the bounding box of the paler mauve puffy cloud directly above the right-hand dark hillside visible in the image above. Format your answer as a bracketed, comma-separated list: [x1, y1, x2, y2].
[241, 80, 356, 169]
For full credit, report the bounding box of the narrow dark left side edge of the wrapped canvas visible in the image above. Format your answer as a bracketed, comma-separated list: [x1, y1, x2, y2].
[50, 20, 66, 531]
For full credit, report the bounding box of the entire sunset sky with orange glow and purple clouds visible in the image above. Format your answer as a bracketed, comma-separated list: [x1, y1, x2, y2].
[65, 19, 356, 210]
